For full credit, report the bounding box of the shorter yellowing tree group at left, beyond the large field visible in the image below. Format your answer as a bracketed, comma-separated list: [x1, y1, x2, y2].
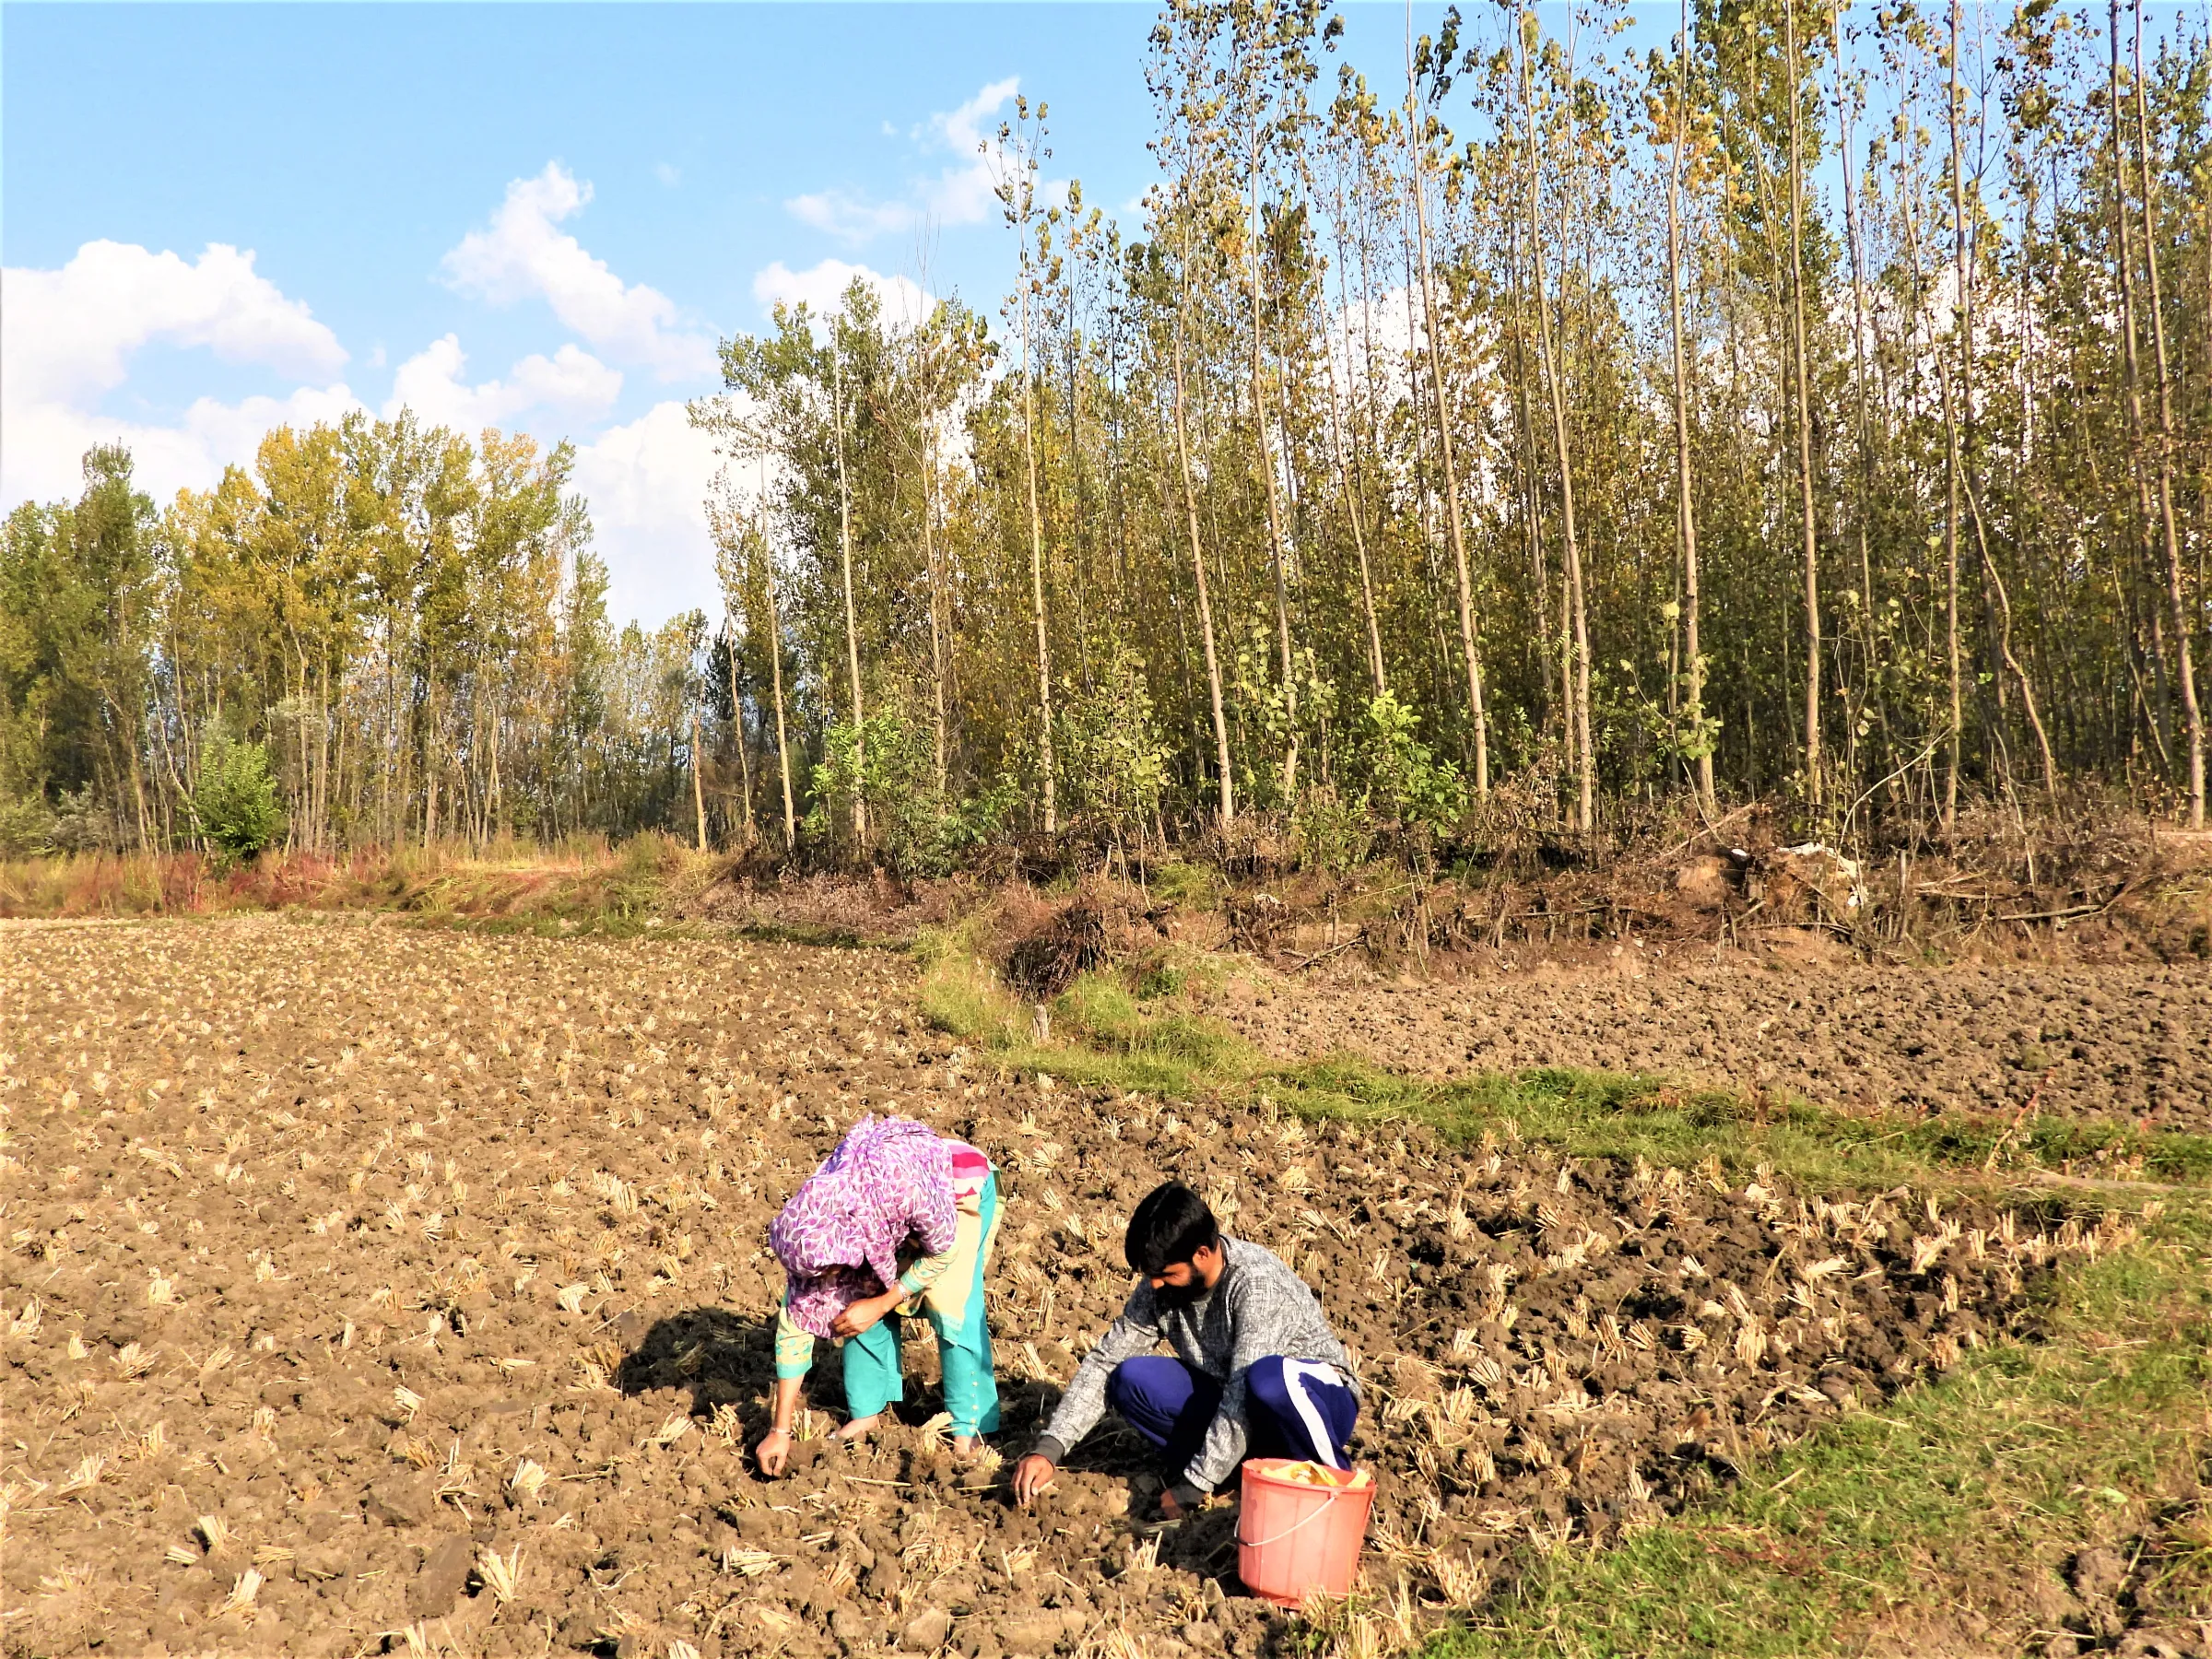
[0, 414, 721, 852]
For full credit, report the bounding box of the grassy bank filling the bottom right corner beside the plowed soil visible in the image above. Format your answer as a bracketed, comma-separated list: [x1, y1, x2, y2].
[1429, 1215, 2212, 1659]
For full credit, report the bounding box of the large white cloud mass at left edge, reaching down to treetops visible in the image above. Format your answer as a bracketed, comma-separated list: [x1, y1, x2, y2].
[0, 241, 360, 504]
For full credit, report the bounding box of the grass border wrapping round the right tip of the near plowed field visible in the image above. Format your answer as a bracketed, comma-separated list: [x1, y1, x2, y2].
[923, 938, 2212, 1659]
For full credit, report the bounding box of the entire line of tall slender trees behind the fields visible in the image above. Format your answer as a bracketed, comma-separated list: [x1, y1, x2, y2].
[0, 0, 2212, 869]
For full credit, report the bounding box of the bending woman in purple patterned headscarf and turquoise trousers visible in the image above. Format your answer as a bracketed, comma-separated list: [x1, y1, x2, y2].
[757, 1117, 997, 1476]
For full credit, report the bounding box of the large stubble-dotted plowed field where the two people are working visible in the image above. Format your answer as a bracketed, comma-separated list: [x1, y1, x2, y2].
[0, 918, 2141, 1659]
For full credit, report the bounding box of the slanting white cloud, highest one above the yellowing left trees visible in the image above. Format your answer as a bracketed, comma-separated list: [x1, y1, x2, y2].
[444, 161, 717, 381]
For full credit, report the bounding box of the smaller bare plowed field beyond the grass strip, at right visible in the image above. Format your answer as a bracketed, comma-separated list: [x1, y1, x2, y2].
[1228, 949, 2212, 1133]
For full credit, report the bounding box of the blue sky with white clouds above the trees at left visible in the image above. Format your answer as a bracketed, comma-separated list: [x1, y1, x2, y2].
[0, 0, 1593, 621]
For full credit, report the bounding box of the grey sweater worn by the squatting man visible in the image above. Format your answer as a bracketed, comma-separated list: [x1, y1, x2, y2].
[1038, 1239, 1359, 1491]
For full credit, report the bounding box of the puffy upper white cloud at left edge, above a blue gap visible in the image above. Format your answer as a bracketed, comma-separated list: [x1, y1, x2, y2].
[0, 241, 345, 403]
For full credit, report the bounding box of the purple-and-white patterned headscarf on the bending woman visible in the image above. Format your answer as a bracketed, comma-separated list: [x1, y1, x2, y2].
[768, 1117, 958, 1336]
